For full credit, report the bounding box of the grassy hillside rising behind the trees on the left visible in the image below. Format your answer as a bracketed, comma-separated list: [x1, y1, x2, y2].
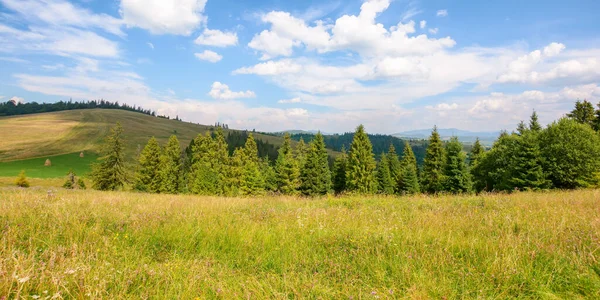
[0, 109, 298, 178]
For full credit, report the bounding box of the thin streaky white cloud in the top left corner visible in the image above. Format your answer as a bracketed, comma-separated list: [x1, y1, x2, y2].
[0, 0, 125, 36]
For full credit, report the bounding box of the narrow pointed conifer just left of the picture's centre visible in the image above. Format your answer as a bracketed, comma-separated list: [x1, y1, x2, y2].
[275, 133, 300, 195]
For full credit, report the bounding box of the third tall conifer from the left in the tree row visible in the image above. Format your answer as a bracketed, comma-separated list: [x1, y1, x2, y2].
[160, 135, 183, 194]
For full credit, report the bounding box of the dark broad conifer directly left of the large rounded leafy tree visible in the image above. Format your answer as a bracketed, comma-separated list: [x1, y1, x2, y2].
[508, 132, 548, 190]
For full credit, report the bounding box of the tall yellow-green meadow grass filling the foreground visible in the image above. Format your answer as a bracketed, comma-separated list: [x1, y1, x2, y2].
[0, 188, 600, 299]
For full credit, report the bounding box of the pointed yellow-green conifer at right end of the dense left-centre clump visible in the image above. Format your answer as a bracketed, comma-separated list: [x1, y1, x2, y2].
[240, 134, 265, 195]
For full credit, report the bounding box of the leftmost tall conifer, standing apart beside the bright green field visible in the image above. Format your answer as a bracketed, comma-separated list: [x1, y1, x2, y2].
[90, 122, 126, 191]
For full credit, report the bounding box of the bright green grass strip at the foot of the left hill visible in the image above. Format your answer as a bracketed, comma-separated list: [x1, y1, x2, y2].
[0, 151, 98, 178]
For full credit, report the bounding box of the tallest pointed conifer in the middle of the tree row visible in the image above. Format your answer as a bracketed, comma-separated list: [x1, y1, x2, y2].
[346, 125, 377, 193]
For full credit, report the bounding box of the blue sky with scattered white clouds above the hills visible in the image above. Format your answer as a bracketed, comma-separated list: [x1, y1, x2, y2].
[0, 0, 600, 134]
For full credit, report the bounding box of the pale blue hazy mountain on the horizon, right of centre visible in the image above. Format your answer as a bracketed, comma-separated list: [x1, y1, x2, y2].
[392, 128, 500, 145]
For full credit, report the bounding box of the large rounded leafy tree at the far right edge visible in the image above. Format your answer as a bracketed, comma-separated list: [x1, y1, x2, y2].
[539, 118, 600, 189]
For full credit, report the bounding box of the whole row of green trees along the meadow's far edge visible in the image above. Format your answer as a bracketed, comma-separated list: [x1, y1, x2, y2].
[91, 102, 600, 196]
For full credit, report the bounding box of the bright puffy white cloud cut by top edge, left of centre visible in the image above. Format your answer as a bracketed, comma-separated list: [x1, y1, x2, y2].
[119, 0, 206, 36]
